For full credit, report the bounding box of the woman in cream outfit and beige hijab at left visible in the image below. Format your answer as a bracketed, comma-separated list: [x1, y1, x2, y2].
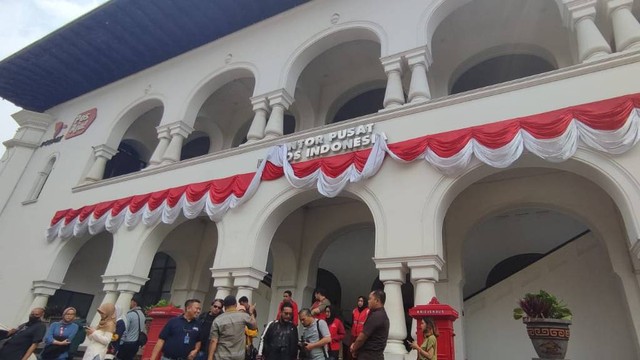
[82, 304, 116, 360]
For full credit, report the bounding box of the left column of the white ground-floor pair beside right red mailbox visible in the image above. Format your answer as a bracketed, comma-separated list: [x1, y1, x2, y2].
[374, 259, 407, 360]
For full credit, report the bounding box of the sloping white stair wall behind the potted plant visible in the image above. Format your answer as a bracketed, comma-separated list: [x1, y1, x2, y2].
[464, 234, 638, 360]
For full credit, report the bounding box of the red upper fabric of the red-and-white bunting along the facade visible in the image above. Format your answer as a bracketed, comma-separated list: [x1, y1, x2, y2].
[51, 94, 640, 226]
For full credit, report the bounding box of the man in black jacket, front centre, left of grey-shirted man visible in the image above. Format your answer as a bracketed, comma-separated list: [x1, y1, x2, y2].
[258, 302, 298, 360]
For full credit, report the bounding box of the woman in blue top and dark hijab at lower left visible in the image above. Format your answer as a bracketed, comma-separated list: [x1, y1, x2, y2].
[40, 307, 78, 360]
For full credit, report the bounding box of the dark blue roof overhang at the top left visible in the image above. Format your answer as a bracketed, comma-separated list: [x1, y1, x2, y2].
[0, 0, 310, 112]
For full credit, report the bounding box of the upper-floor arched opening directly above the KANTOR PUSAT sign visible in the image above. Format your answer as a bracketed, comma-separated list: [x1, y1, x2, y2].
[293, 33, 386, 129]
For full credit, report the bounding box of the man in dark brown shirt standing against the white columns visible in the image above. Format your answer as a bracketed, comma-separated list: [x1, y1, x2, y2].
[350, 290, 389, 360]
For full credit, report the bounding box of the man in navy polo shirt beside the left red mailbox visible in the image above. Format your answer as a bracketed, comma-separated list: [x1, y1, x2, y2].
[151, 299, 202, 360]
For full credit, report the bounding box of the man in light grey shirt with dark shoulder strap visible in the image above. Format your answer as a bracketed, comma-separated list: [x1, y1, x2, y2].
[299, 308, 331, 360]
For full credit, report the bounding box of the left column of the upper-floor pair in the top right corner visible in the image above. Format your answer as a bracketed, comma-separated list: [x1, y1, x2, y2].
[563, 0, 611, 63]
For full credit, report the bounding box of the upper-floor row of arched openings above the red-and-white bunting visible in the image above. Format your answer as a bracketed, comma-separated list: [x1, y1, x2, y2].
[81, 0, 632, 179]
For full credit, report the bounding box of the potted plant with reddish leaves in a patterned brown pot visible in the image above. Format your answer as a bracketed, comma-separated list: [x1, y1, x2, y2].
[513, 290, 572, 359]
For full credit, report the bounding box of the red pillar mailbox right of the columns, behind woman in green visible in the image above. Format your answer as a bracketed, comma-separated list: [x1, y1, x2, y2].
[409, 297, 458, 360]
